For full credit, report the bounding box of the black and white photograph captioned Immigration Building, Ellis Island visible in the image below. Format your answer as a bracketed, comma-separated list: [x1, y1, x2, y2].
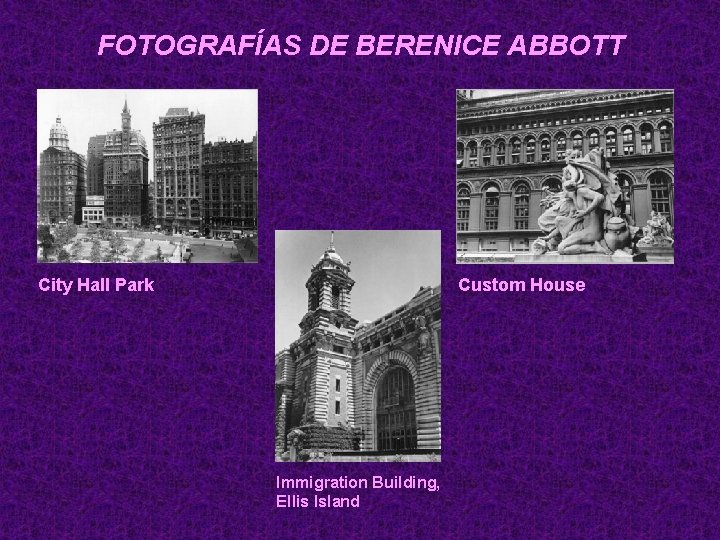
[275, 230, 441, 462]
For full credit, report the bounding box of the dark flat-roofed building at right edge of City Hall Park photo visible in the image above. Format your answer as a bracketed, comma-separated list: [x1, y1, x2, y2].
[202, 135, 258, 236]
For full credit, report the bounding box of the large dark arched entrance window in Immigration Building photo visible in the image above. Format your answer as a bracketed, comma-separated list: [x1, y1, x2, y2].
[375, 366, 417, 451]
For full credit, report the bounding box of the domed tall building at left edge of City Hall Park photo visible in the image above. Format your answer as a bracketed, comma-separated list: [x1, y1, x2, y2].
[38, 117, 85, 225]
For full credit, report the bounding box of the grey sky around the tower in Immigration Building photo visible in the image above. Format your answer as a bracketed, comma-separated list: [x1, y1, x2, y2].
[275, 231, 440, 352]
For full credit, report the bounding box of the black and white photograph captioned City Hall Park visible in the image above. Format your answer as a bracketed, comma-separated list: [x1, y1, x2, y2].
[37, 89, 258, 263]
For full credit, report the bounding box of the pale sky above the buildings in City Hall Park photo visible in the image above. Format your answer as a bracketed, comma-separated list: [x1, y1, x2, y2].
[37, 90, 258, 173]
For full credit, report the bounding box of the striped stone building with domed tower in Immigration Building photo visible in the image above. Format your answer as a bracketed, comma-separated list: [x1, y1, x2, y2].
[275, 243, 441, 454]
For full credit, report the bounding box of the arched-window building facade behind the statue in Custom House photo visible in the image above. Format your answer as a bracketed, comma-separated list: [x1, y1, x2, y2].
[456, 90, 675, 254]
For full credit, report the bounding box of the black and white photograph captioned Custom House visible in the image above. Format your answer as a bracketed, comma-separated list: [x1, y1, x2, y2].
[455, 89, 675, 264]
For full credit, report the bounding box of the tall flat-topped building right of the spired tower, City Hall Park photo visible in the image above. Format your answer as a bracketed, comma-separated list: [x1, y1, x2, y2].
[153, 108, 205, 232]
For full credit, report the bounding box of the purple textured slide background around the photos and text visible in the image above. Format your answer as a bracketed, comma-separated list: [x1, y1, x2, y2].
[0, 0, 720, 538]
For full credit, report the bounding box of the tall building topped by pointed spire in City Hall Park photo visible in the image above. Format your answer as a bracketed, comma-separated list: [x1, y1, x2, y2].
[103, 100, 149, 227]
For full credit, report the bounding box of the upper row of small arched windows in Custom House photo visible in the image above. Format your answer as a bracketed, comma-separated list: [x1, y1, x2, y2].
[456, 122, 673, 167]
